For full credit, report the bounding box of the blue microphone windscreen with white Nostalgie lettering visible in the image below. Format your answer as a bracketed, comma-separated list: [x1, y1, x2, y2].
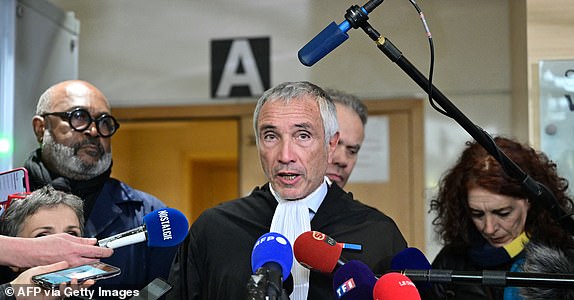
[143, 208, 189, 247]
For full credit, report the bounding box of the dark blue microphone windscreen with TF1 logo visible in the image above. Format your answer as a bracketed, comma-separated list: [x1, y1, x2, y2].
[333, 260, 377, 299]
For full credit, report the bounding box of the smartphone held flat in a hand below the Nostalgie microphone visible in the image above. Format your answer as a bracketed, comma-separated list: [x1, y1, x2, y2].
[32, 262, 120, 289]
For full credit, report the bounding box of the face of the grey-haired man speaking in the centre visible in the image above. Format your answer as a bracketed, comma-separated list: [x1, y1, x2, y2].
[257, 96, 337, 200]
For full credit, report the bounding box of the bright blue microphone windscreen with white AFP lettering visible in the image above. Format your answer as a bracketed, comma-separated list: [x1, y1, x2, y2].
[251, 232, 293, 281]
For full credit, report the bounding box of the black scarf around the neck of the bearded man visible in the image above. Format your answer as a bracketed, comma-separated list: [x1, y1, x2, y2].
[24, 149, 112, 220]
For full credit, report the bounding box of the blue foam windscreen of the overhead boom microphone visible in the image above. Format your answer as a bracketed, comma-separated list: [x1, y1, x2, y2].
[297, 22, 349, 67]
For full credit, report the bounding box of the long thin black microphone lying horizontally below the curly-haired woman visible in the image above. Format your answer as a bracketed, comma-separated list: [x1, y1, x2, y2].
[399, 269, 574, 288]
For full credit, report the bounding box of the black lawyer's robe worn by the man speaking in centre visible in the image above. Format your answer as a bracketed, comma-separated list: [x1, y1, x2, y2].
[168, 184, 407, 300]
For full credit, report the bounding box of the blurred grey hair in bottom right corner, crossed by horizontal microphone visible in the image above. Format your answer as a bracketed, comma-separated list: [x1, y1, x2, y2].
[520, 241, 574, 299]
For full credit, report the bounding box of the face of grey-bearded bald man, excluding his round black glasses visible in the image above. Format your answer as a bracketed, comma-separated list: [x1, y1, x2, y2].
[38, 83, 112, 180]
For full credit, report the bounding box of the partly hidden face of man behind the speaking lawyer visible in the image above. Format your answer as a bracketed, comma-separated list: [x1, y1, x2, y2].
[327, 103, 365, 187]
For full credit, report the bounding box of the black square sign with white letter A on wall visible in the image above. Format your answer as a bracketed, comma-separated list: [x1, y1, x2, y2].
[211, 38, 271, 98]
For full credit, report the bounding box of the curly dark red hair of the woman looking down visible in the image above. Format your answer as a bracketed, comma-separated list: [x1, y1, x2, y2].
[430, 137, 572, 246]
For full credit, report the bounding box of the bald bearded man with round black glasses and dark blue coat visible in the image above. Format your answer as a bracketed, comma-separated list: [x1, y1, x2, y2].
[24, 80, 176, 290]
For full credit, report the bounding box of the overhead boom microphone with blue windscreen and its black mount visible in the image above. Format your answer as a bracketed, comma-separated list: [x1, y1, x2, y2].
[297, 0, 383, 67]
